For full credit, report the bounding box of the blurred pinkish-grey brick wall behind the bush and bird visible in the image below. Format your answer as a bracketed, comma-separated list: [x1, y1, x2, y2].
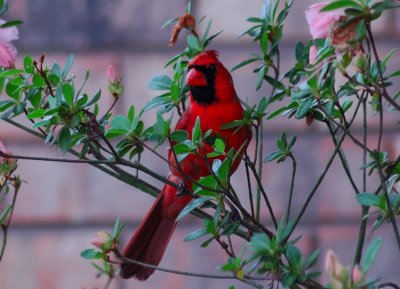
[0, 0, 400, 289]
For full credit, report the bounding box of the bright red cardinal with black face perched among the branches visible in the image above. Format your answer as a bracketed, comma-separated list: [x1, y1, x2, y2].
[120, 51, 251, 280]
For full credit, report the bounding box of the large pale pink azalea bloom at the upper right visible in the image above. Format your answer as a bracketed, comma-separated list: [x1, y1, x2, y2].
[306, 1, 342, 39]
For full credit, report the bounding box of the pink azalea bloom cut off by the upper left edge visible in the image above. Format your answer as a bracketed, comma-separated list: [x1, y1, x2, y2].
[0, 19, 18, 68]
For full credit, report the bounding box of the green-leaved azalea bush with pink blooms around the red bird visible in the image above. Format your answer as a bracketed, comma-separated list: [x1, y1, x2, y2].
[0, 0, 400, 288]
